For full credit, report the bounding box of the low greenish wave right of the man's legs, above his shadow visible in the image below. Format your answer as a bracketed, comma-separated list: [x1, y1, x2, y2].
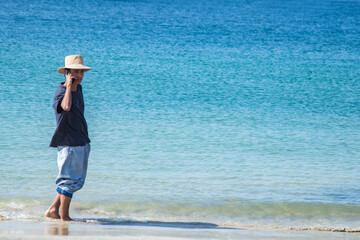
[76, 201, 360, 219]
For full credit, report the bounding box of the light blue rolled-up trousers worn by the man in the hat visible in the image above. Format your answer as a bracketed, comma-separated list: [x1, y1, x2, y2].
[56, 144, 90, 197]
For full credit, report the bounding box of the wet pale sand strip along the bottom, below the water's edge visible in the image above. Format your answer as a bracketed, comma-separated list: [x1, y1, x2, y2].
[0, 218, 360, 240]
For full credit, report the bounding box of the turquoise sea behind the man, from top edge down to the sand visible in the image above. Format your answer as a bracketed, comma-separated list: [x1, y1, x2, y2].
[0, 0, 360, 228]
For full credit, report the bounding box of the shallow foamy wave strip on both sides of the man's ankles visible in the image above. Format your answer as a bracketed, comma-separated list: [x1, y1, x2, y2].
[0, 199, 360, 233]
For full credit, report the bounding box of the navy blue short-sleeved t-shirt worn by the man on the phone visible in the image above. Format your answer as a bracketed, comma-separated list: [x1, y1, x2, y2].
[50, 83, 90, 147]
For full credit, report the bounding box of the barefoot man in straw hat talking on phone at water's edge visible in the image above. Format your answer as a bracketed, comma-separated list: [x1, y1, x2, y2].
[45, 55, 91, 221]
